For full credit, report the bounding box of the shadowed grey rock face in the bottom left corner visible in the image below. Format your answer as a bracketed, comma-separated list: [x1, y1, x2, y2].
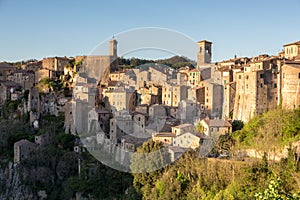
[0, 162, 38, 200]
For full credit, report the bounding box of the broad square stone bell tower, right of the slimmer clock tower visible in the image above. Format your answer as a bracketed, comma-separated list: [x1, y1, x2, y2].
[197, 40, 212, 67]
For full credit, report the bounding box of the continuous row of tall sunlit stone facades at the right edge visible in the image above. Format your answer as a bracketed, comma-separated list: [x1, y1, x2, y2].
[217, 43, 300, 121]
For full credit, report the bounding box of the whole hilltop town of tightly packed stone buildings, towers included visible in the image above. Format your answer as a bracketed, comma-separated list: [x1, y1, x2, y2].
[0, 39, 300, 170]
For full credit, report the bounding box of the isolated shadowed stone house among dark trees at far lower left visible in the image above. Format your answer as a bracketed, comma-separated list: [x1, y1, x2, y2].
[14, 140, 37, 163]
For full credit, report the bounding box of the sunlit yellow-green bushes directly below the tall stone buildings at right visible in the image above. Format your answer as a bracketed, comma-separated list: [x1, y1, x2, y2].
[234, 108, 300, 151]
